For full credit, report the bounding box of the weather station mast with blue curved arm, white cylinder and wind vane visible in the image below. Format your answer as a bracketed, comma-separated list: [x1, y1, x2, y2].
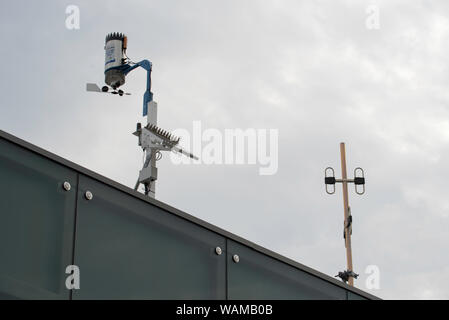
[86, 32, 198, 198]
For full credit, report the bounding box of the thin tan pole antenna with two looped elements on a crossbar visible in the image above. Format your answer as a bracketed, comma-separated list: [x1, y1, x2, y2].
[324, 142, 365, 286]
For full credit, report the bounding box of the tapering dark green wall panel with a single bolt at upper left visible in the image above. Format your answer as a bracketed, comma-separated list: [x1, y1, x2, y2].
[227, 240, 346, 300]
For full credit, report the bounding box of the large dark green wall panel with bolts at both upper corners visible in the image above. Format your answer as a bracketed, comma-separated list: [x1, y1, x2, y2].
[73, 175, 226, 299]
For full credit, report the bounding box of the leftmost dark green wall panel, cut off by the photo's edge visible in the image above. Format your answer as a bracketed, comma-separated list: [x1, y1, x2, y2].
[0, 139, 77, 299]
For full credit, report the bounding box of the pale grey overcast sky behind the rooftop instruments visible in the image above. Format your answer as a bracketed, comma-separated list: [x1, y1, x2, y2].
[0, 0, 449, 299]
